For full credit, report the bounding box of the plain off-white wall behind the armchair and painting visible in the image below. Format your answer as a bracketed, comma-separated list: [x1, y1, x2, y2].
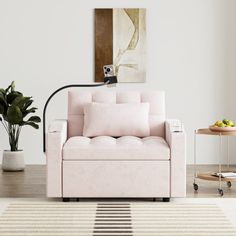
[0, 0, 236, 164]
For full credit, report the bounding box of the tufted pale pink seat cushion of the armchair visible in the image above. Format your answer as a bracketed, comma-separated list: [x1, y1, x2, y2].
[63, 136, 170, 160]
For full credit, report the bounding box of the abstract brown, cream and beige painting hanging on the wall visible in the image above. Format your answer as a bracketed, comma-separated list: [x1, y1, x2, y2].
[95, 8, 146, 83]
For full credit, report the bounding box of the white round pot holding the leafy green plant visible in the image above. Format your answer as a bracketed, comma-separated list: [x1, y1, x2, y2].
[2, 150, 25, 171]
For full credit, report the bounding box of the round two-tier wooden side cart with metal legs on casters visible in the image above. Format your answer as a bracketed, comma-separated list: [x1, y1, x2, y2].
[193, 128, 236, 196]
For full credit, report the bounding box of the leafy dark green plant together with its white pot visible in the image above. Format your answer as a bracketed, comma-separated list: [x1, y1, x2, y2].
[0, 81, 41, 171]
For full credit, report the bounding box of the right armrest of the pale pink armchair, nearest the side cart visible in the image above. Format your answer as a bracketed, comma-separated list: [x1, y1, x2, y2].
[165, 120, 186, 197]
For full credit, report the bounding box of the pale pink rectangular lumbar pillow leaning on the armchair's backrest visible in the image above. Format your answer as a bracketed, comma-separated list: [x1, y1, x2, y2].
[83, 103, 150, 137]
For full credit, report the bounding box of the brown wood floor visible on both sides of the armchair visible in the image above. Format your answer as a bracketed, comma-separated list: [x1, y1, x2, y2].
[0, 165, 236, 198]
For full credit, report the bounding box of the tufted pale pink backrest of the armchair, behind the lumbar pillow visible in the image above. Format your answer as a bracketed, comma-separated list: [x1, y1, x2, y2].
[68, 89, 165, 138]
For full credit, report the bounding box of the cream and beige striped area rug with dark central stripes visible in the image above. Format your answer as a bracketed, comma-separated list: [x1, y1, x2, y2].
[0, 202, 236, 236]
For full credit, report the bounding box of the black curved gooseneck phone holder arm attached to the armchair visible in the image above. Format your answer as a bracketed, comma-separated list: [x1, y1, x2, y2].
[43, 76, 117, 152]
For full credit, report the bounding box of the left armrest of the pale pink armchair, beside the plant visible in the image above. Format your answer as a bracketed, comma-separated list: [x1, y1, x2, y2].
[46, 120, 67, 197]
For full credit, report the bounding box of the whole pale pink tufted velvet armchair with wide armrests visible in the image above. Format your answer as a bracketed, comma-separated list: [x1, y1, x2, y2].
[46, 90, 186, 201]
